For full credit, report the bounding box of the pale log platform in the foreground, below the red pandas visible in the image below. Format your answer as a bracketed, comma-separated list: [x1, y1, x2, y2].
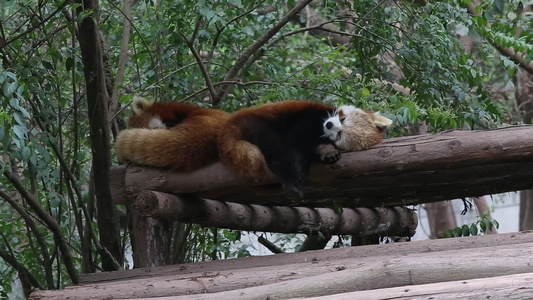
[30, 233, 533, 300]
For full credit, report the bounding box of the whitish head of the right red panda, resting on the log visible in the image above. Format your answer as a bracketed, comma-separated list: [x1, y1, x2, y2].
[324, 105, 392, 151]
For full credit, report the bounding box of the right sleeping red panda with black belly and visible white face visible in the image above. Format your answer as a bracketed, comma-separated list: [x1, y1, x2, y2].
[218, 100, 392, 197]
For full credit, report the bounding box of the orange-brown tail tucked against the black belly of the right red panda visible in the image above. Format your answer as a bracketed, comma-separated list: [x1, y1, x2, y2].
[218, 126, 274, 178]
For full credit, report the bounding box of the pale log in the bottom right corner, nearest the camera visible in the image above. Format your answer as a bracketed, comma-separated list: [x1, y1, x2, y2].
[290, 273, 533, 300]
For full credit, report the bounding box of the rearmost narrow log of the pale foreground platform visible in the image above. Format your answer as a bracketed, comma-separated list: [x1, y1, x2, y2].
[80, 232, 533, 284]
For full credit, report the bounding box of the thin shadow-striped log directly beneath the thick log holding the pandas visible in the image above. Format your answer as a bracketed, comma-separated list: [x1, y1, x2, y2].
[134, 191, 418, 236]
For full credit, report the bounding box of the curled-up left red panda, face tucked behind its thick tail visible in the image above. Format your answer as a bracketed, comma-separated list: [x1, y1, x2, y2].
[116, 98, 229, 171]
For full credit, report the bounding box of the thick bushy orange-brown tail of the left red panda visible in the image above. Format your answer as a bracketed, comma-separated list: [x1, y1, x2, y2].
[116, 126, 218, 171]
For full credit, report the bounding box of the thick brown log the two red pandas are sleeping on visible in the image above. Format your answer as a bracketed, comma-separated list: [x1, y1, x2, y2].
[110, 125, 533, 207]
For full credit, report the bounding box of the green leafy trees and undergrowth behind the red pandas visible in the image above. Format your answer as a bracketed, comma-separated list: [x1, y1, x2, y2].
[0, 0, 533, 298]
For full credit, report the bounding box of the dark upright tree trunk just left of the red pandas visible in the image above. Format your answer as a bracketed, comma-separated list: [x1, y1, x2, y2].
[76, 0, 123, 271]
